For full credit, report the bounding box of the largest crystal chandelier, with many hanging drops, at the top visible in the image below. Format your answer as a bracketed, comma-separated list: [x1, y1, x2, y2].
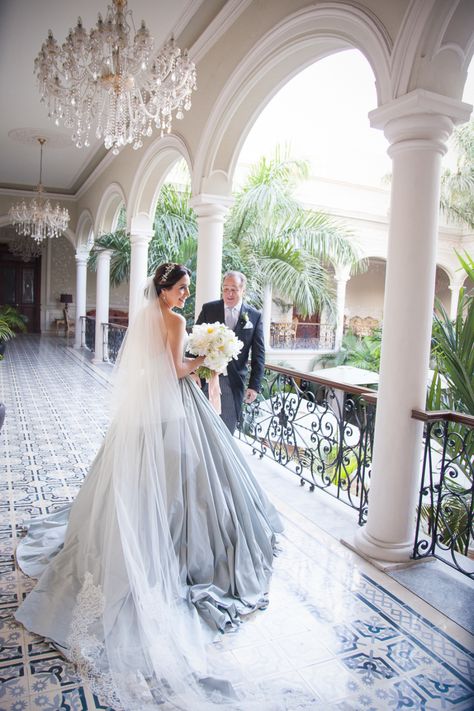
[35, 0, 196, 154]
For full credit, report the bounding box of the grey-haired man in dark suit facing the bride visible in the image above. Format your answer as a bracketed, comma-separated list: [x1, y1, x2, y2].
[196, 272, 265, 434]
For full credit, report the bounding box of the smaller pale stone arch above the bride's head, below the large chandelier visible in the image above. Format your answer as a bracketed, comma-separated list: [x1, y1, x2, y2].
[127, 135, 192, 226]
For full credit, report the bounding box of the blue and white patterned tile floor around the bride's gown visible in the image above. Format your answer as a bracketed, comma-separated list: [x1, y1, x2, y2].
[0, 336, 474, 711]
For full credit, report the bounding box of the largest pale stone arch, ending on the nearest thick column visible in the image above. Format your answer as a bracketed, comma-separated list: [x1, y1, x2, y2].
[193, 2, 391, 195]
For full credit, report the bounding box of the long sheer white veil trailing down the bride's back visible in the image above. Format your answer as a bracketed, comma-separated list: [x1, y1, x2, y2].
[68, 281, 241, 711]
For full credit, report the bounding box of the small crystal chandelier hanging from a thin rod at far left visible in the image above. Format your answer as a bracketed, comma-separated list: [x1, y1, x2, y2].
[8, 138, 69, 242]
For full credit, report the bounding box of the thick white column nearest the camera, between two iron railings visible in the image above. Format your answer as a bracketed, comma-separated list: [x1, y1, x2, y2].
[355, 90, 469, 561]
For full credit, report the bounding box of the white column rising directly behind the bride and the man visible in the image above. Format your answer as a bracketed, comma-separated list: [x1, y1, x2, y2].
[189, 194, 232, 317]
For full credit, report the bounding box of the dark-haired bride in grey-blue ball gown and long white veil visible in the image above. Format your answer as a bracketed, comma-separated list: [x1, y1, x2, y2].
[16, 263, 282, 711]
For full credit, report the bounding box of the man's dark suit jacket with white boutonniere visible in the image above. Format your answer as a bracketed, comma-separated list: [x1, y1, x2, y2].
[196, 299, 265, 412]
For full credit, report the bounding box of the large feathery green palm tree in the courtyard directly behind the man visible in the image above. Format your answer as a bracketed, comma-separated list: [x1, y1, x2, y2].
[224, 147, 363, 316]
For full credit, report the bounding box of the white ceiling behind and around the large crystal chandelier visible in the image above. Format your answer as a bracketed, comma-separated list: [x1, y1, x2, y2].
[0, 0, 201, 193]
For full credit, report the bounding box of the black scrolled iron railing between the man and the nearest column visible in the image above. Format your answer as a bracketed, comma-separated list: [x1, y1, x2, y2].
[238, 365, 376, 524]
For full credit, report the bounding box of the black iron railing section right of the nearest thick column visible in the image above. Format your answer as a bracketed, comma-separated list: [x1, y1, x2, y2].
[412, 410, 474, 578]
